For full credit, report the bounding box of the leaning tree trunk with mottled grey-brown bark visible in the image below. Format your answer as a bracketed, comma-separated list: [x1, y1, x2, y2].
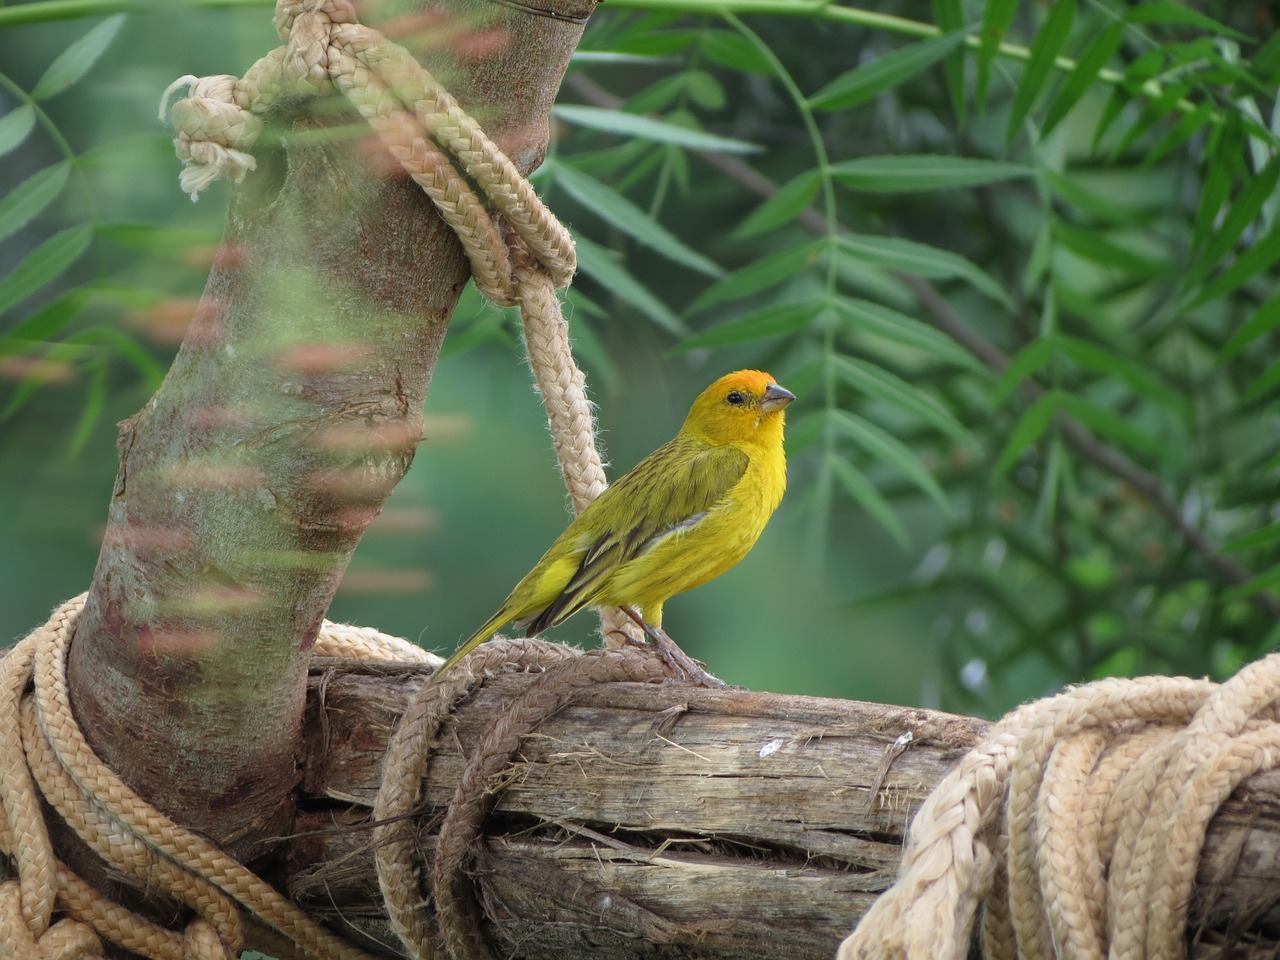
[69, 0, 594, 859]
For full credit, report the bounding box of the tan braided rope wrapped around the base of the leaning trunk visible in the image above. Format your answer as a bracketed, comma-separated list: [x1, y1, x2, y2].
[0, 594, 434, 960]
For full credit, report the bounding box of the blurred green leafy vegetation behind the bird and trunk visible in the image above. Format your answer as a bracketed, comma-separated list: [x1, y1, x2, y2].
[0, 0, 1280, 714]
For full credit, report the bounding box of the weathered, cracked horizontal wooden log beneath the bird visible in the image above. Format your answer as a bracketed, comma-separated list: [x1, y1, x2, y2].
[285, 660, 1280, 960]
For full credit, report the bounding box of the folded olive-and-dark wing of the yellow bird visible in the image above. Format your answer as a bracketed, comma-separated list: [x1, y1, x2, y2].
[520, 438, 749, 636]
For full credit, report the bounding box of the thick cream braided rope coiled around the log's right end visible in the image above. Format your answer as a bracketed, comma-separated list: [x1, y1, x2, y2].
[838, 654, 1280, 960]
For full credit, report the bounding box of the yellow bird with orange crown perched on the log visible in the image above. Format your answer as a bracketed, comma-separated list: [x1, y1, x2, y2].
[434, 370, 795, 682]
